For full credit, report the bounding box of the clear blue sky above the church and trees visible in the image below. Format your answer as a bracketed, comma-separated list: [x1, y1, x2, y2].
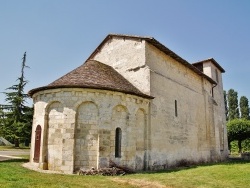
[0, 0, 250, 103]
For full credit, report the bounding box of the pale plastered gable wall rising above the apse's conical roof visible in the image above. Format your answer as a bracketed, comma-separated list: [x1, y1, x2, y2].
[93, 37, 150, 94]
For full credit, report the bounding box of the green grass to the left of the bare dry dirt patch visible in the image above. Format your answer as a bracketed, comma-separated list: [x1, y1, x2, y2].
[0, 159, 133, 188]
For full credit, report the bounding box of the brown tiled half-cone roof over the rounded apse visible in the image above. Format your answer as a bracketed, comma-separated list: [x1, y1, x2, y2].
[29, 60, 153, 98]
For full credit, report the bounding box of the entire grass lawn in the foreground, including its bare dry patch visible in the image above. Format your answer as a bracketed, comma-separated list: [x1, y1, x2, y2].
[0, 159, 250, 188]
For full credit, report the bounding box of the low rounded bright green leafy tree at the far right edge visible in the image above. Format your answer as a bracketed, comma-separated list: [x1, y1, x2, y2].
[227, 119, 250, 153]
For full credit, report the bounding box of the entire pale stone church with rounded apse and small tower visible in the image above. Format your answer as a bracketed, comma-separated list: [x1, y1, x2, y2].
[29, 34, 228, 174]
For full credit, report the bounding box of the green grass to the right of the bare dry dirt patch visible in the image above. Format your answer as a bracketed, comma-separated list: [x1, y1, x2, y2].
[124, 161, 250, 188]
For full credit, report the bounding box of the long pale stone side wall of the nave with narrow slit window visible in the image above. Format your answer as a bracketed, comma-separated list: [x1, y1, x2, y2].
[145, 43, 227, 168]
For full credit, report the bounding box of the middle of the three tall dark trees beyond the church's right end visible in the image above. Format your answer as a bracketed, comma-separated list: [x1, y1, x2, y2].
[227, 89, 239, 120]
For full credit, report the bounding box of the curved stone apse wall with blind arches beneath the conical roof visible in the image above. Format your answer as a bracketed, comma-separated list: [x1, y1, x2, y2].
[30, 88, 150, 173]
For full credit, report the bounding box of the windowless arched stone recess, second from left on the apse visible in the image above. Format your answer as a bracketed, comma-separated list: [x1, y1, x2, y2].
[74, 102, 99, 170]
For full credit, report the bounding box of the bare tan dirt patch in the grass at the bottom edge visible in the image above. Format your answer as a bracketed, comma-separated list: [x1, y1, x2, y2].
[111, 178, 171, 188]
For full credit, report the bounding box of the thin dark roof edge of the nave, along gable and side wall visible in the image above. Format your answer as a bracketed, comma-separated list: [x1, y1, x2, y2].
[88, 34, 219, 84]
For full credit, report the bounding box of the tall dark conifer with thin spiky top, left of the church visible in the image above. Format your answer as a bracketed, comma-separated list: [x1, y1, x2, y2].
[0, 52, 33, 147]
